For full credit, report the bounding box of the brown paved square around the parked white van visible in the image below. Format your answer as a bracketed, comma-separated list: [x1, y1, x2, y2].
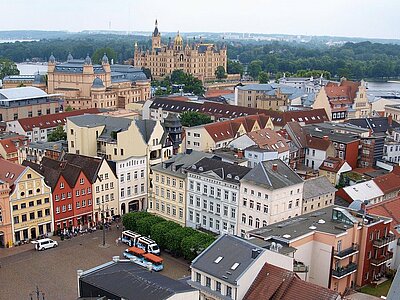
[0, 227, 190, 300]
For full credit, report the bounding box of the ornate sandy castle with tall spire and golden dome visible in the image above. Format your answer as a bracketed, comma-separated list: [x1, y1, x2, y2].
[134, 20, 227, 81]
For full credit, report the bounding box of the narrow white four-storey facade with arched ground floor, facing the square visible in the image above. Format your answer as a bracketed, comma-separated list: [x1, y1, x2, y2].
[115, 156, 147, 215]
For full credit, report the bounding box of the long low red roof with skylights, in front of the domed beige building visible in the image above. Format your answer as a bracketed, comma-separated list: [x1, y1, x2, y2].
[18, 108, 101, 132]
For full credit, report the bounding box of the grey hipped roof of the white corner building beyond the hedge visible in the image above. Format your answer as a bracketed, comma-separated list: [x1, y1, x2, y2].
[242, 159, 303, 190]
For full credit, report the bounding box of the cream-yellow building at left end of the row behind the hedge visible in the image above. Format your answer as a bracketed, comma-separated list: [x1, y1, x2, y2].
[148, 151, 212, 226]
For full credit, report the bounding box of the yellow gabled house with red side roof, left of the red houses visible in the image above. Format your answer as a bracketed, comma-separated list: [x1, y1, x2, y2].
[0, 159, 54, 245]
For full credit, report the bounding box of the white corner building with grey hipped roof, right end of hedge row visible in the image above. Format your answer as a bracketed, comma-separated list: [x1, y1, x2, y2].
[238, 159, 304, 236]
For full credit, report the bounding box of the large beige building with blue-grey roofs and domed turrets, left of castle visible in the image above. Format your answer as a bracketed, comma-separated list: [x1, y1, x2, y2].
[47, 54, 150, 109]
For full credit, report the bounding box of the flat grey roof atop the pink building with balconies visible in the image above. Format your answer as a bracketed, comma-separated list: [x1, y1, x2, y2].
[248, 205, 388, 244]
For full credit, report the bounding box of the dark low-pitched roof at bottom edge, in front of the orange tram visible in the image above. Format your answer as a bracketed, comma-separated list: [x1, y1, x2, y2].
[79, 261, 195, 300]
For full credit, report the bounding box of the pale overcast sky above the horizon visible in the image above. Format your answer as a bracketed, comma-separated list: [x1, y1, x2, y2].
[0, 0, 400, 39]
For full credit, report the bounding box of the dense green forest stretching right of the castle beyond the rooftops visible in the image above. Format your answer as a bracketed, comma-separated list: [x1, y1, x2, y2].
[228, 42, 400, 79]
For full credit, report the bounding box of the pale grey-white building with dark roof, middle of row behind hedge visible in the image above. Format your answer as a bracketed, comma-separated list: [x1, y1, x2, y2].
[186, 158, 250, 234]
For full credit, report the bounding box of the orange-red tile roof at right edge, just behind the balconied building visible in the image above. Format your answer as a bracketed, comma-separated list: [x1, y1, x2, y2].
[367, 197, 400, 238]
